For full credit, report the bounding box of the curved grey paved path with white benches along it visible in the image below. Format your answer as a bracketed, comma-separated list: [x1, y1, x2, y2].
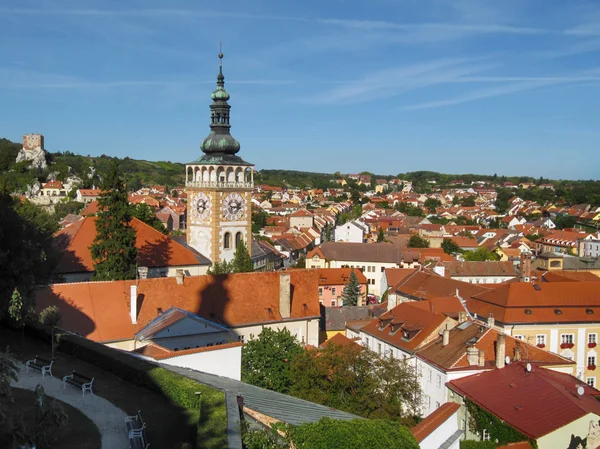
[12, 365, 129, 449]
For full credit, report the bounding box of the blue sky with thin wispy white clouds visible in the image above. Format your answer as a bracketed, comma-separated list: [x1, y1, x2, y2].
[0, 0, 600, 179]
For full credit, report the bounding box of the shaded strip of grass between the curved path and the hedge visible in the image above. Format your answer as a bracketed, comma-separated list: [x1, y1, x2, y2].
[0, 326, 198, 449]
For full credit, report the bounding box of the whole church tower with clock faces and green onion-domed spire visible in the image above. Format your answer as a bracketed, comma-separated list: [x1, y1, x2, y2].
[185, 53, 254, 263]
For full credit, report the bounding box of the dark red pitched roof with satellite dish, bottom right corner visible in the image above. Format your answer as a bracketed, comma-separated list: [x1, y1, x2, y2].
[446, 362, 600, 439]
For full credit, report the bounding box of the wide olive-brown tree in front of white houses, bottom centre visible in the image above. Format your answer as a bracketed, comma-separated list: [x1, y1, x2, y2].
[290, 344, 421, 425]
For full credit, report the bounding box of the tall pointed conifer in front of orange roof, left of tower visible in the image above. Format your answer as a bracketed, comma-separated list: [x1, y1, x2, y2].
[90, 162, 137, 281]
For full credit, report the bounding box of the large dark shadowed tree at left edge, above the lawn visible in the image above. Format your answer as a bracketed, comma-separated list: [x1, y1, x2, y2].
[0, 192, 58, 317]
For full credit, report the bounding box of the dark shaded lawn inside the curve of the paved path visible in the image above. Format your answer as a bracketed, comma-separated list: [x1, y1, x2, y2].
[8, 388, 102, 449]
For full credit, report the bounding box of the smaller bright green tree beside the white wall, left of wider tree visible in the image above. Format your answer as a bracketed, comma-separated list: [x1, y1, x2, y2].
[242, 327, 303, 393]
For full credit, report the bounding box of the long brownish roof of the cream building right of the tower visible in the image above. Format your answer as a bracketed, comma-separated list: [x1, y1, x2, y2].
[319, 242, 402, 263]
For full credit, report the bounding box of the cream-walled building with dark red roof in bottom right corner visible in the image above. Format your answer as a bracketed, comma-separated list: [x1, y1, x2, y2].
[448, 362, 600, 449]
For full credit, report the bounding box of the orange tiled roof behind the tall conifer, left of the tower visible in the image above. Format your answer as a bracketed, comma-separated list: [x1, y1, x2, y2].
[54, 216, 210, 274]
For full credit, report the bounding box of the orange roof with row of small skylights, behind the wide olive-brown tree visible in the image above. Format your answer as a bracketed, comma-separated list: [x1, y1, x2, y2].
[361, 302, 447, 352]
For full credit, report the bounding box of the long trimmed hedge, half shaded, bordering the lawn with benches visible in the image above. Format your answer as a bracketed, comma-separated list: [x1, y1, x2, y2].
[39, 328, 227, 449]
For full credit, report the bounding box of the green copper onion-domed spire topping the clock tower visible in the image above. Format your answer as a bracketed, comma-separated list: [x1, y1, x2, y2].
[195, 53, 251, 165]
